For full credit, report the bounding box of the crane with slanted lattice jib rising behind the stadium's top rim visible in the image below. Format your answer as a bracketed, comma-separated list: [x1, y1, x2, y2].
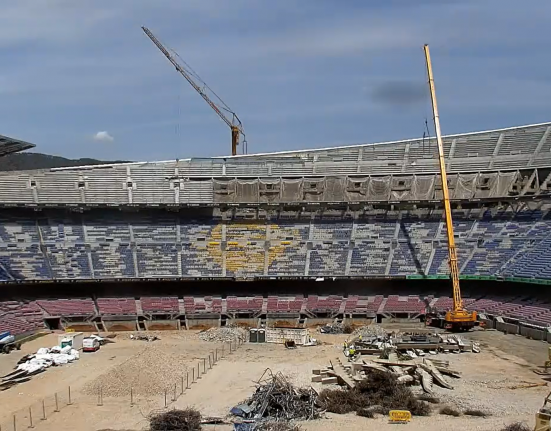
[142, 27, 247, 156]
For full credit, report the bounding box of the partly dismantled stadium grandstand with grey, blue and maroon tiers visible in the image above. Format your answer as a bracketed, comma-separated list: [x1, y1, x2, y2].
[0, 123, 551, 334]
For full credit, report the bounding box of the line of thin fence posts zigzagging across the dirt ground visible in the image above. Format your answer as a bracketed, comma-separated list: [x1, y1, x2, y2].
[0, 339, 243, 431]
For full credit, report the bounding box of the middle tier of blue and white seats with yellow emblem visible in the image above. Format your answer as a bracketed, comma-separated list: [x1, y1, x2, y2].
[0, 210, 551, 281]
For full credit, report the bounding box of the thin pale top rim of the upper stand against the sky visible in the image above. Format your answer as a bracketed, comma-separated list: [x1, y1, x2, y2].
[41, 121, 551, 172]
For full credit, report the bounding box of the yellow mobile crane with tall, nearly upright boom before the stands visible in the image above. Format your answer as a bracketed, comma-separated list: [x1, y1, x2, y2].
[424, 45, 476, 331]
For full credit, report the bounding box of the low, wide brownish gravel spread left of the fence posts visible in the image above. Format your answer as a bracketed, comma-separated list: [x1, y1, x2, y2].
[83, 345, 189, 397]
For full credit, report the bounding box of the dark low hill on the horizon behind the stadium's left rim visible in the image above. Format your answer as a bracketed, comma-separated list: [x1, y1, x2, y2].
[0, 153, 129, 171]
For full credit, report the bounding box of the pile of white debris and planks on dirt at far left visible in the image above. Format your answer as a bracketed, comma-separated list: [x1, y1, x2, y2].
[0, 346, 80, 391]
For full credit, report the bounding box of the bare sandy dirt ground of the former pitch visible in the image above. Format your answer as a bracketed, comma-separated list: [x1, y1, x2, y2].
[0, 331, 550, 431]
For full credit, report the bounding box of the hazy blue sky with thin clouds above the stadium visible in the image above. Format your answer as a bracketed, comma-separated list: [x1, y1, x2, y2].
[0, 0, 551, 160]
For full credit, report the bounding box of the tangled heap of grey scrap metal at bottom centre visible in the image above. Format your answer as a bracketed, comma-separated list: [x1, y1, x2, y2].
[231, 369, 322, 430]
